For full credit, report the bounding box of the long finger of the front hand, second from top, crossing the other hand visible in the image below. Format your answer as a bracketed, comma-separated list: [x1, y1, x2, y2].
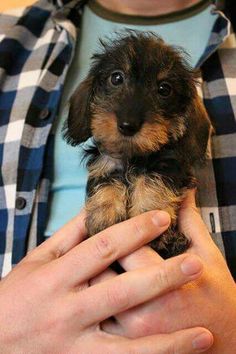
[70, 255, 203, 327]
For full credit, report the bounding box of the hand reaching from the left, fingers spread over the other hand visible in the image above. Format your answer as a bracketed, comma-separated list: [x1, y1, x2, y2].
[0, 212, 212, 354]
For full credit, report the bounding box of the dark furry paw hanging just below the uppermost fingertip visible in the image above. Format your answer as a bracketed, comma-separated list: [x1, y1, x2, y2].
[150, 229, 191, 259]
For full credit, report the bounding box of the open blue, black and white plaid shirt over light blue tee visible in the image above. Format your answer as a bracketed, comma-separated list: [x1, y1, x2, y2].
[0, 0, 236, 276]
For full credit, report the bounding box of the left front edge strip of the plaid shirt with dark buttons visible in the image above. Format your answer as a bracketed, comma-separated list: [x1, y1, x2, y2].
[12, 5, 76, 265]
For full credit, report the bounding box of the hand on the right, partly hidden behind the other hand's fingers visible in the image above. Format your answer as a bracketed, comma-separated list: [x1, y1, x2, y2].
[104, 191, 236, 354]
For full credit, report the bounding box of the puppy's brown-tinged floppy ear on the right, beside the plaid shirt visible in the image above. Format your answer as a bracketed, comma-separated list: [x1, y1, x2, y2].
[181, 96, 212, 164]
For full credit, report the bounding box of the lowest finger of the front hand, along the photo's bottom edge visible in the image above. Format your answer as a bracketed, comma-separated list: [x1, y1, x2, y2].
[74, 327, 214, 354]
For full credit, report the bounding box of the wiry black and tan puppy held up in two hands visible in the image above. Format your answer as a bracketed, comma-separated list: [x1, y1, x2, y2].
[65, 31, 211, 258]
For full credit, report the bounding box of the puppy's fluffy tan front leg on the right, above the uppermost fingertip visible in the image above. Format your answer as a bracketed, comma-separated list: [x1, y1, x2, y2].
[128, 174, 184, 223]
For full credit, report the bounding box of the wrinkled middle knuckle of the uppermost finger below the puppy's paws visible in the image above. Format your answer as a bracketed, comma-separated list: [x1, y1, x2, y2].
[95, 235, 117, 259]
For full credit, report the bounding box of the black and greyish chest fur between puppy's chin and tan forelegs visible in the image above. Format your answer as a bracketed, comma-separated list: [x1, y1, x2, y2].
[86, 144, 191, 195]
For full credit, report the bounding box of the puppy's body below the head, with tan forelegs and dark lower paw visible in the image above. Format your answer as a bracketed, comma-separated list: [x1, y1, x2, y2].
[83, 144, 190, 258]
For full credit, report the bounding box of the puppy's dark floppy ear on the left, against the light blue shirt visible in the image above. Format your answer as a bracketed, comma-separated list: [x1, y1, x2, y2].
[63, 76, 93, 146]
